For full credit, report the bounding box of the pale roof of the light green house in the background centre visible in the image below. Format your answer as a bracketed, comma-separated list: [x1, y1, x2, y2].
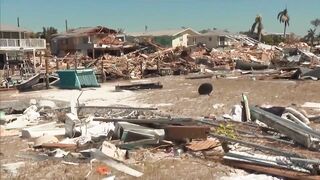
[128, 28, 200, 37]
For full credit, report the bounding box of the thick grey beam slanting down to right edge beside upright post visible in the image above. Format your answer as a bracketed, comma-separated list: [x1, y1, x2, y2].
[250, 107, 320, 149]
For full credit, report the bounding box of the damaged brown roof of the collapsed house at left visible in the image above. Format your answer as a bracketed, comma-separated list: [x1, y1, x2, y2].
[54, 26, 117, 38]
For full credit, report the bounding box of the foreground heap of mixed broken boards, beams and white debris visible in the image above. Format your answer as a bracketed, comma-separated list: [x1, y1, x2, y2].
[0, 94, 320, 179]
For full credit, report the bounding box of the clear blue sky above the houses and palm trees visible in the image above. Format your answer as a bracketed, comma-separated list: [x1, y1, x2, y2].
[0, 0, 320, 35]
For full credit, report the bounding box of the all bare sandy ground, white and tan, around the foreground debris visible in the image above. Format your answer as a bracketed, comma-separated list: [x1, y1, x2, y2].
[0, 76, 320, 179]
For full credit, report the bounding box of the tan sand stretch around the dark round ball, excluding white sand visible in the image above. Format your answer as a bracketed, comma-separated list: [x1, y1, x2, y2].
[136, 76, 320, 117]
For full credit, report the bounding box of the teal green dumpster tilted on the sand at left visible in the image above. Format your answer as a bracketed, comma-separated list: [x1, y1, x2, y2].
[57, 69, 100, 89]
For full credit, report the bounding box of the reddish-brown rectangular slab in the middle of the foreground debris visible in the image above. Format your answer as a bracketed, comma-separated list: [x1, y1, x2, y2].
[164, 126, 210, 141]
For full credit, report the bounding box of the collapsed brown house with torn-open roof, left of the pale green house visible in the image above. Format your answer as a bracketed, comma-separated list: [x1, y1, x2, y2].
[51, 26, 133, 58]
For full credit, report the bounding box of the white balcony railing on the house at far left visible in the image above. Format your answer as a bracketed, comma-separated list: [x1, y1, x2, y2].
[0, 39, 46, 50]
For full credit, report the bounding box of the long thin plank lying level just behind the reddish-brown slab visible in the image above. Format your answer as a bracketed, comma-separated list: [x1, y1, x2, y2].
[93, 117, 193, 124]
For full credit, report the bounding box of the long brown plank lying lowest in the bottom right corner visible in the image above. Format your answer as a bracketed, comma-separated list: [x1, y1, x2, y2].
[224, 160, 320, 180]
